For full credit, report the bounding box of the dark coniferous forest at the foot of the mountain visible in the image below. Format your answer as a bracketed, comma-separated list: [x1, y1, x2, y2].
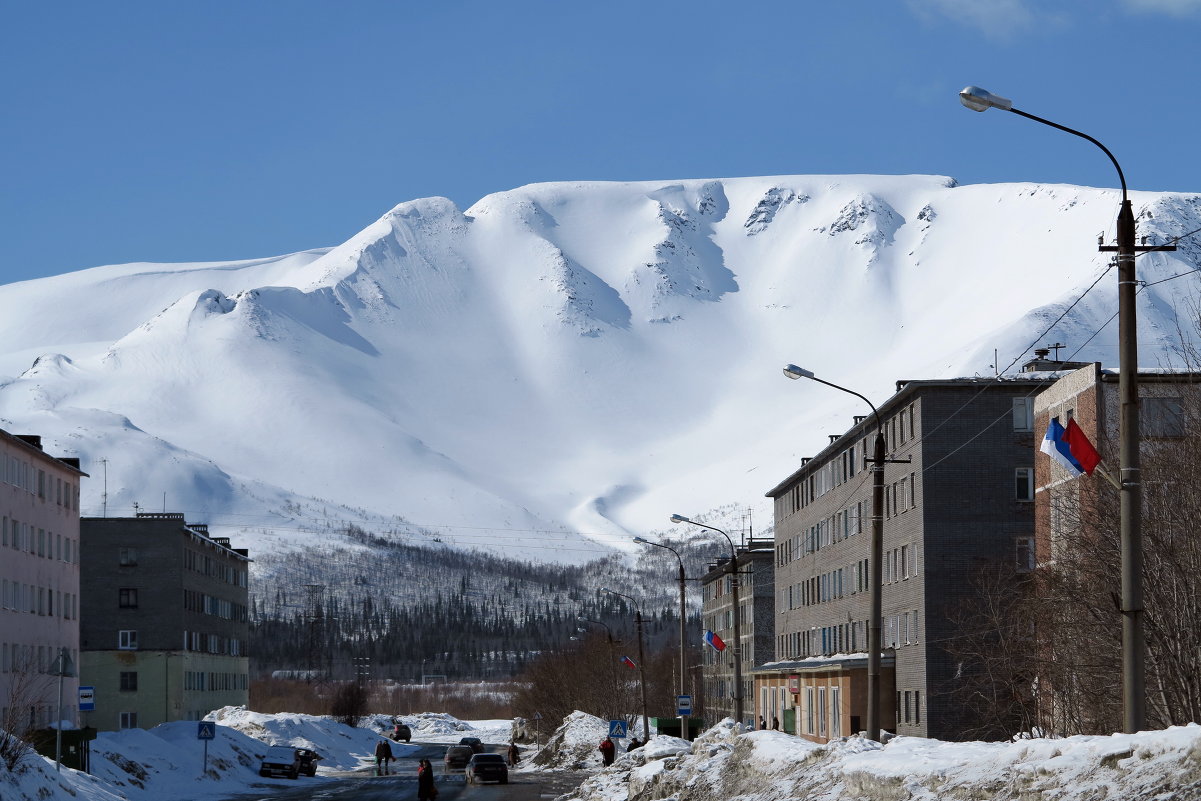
[242, 527, 719, 682]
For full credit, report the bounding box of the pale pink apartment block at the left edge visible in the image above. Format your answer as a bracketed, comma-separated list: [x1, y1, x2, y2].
[0, 431, 85, 734]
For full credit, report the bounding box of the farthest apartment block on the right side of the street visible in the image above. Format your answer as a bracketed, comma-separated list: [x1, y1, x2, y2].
[701, 539, 775, 728]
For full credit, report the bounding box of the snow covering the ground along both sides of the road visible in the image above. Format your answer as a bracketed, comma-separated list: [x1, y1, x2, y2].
[0, 707, 1201, 801]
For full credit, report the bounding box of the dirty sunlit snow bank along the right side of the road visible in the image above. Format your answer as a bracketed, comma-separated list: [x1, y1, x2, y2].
[563, 721, 1201, 801]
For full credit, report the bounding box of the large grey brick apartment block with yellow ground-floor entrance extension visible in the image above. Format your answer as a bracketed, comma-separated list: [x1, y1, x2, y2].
[755, 365, 1051, 742]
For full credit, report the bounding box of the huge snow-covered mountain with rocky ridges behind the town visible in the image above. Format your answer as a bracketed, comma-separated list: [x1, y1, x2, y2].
[0, 175, 1201, 561]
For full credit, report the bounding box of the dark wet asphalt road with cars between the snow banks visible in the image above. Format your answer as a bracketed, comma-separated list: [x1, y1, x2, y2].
[228, 742, 586, 801]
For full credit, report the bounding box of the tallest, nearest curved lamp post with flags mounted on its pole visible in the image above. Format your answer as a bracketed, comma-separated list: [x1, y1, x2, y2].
[960, 86, 1143, 733]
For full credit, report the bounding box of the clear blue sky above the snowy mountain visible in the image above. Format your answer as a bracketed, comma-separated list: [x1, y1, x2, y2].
[7, 0, 1201, 282]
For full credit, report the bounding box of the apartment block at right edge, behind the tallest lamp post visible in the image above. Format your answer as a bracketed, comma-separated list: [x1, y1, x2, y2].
[1029, 363, 1201, 734]
